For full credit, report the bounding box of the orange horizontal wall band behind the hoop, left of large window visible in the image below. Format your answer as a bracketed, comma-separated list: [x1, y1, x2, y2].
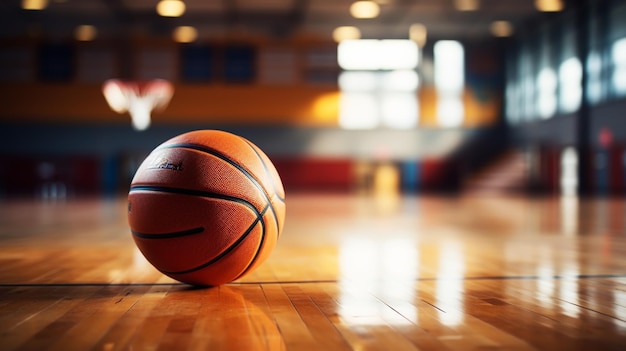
[0, 83, 339, 126]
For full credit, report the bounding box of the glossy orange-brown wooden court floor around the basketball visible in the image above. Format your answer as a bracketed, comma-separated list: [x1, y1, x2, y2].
[0, 194, 626, 351]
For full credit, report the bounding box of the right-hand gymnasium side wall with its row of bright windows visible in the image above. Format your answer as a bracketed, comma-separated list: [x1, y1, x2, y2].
[505, 1, 626, 196]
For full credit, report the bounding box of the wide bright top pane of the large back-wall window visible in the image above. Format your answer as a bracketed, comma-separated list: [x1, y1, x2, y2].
[337, 39, 419, 70]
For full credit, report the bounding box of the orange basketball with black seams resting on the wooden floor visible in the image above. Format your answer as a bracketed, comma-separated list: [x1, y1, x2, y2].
[128, 130, 285, 286]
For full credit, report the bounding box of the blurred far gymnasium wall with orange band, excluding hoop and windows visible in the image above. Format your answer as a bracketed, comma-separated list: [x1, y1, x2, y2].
[0, 36, 502, 196]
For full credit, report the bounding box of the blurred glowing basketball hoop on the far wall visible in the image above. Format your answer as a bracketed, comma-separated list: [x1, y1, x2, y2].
[102, 79, 174, 130]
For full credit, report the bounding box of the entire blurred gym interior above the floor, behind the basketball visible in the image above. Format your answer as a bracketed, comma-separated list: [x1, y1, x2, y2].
[0, 0, 626, 198]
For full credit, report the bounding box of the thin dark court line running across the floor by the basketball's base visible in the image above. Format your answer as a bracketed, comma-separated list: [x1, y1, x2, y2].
[0, 274, 626, 288]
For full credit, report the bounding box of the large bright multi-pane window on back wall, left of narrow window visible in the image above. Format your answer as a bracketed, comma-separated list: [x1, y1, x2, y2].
[337, 40, 419, 129]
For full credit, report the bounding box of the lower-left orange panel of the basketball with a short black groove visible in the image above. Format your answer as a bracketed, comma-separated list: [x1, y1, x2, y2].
[129, 191, 263, 271]
